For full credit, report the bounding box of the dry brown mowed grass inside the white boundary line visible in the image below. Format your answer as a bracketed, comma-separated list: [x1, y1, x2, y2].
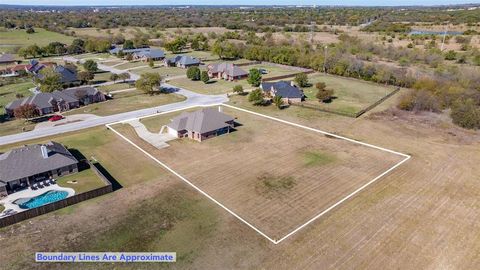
[113, 108, 405, 240]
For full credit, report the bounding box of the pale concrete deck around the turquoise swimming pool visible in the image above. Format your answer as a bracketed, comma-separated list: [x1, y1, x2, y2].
[0, 184, 75, 218]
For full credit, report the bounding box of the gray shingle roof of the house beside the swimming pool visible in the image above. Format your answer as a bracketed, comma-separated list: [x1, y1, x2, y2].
[0, 142, 78, 183]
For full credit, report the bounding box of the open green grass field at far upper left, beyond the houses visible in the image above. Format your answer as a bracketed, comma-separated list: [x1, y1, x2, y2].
[0, 28, 74, 52]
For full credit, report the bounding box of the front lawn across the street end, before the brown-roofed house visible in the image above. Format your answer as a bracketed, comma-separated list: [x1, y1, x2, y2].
[169, 78, 252, 95]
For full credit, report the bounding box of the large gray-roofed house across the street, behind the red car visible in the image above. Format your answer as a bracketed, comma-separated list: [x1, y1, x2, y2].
[5, 86, 105, 117]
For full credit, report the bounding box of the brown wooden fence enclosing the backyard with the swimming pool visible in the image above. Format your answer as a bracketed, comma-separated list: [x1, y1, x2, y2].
[0, 161, 113, 228]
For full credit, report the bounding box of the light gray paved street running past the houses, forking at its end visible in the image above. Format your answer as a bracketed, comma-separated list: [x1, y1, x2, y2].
[0, 83, 228, 145]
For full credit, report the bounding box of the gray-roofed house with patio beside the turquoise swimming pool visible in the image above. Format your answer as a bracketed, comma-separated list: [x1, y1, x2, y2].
[0, 142, 78, 196]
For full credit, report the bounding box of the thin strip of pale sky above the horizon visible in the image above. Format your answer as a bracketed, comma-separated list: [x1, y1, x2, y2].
[0, 0, 480, 6]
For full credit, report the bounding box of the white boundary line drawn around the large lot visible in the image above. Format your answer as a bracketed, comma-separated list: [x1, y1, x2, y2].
[105, 104, 411, 244]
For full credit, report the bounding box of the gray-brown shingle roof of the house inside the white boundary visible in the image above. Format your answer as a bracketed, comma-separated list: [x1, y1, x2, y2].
[167, 108, 234, 134]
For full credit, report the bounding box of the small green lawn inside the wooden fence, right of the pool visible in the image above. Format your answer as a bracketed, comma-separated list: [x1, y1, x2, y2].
[57, 168, 105, 194]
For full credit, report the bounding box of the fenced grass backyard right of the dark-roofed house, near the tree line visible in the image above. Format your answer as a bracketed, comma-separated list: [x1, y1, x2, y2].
[303, 73, 395, 114]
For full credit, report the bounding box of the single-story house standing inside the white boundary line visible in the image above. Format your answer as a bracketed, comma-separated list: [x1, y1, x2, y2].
[167, 107, 234, 142]
